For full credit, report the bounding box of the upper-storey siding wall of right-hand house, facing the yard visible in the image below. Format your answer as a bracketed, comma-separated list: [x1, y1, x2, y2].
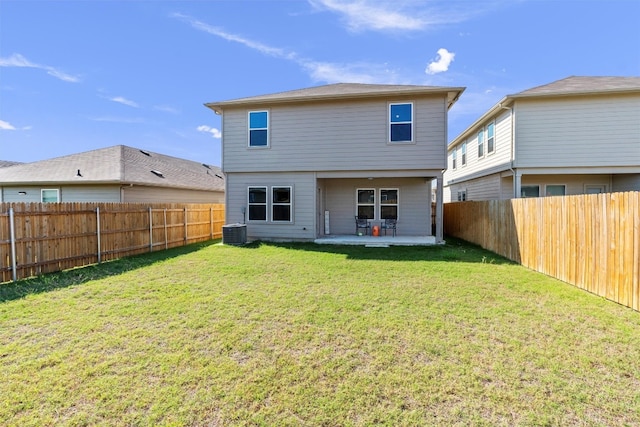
[516, 94, 640, 167]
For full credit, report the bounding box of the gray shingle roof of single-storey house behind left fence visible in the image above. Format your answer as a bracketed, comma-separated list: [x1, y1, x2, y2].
[0, 145, 224, 191]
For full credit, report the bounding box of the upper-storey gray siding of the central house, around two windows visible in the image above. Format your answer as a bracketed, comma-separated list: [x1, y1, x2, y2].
[223, 97, 446, 172]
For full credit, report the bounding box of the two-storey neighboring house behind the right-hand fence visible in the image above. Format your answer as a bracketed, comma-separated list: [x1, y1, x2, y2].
[444, 77, 640, 202]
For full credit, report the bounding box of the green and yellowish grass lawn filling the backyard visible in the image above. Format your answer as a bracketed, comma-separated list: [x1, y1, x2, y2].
[0, 241, 640, 426]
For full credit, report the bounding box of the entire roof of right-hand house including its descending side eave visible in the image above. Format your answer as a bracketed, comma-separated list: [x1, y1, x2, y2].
[448, 76, 640, 149]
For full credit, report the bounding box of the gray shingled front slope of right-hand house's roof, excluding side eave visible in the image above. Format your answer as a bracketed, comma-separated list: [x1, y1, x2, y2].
[509, 76, 640, 98]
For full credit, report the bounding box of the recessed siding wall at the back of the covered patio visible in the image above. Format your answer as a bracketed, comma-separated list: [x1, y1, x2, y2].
[323, 178, 431, 236]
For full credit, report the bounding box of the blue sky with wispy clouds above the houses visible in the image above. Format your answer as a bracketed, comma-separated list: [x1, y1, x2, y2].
[0, 0, 640, 165]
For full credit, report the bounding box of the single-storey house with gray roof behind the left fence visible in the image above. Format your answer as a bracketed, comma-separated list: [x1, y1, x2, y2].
[0, 145, 224, 203]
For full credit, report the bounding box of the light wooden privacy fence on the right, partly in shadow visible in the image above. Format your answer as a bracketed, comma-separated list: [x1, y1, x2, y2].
[444, 192, 640, 310]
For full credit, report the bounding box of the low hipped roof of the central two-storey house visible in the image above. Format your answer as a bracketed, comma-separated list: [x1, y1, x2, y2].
[205, 83, 465, 113]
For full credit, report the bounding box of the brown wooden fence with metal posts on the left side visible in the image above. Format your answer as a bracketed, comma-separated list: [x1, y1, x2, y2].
[0, 203, 224, 282]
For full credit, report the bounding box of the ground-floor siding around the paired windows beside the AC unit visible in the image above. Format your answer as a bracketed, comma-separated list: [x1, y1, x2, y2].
[226, 173, 316, 241]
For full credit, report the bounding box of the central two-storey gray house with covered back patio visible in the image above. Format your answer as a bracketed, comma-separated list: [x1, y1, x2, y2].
[206, 83, 464, 241]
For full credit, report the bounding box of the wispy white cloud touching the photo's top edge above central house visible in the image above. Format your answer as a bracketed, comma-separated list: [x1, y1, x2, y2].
[308, 0, 429, 31]
